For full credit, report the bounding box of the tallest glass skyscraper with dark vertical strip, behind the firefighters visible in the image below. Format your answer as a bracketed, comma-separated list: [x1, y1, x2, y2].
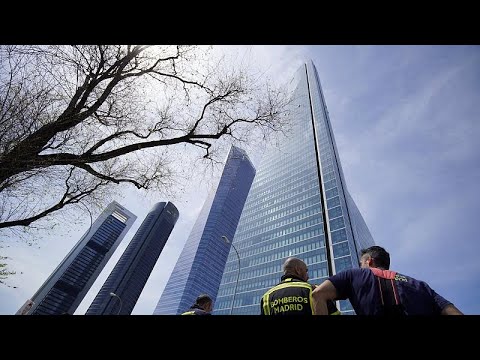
[214, 63, 374, 315]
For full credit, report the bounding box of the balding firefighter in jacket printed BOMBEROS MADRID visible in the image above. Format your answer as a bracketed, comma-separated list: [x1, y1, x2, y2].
[260, 257, 340, 315]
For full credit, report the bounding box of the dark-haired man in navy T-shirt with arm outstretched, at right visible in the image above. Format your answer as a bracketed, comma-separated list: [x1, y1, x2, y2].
[313, 246, 463, 315]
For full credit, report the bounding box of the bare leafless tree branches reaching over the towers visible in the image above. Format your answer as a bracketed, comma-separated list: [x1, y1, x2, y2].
[0, 45, 287, 229]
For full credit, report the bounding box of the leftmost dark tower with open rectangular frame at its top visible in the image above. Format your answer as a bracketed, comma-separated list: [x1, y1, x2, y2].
[17, 201, 137, 315]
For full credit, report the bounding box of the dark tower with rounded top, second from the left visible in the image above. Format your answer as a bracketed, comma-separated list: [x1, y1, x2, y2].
[85, 202, 179, 315]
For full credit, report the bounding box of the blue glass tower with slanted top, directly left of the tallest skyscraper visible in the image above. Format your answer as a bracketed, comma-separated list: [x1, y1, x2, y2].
[153, 146, 255, 315]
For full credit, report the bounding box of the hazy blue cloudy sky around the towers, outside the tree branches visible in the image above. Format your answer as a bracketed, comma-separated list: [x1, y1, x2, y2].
[0, 45, 480, 315]
